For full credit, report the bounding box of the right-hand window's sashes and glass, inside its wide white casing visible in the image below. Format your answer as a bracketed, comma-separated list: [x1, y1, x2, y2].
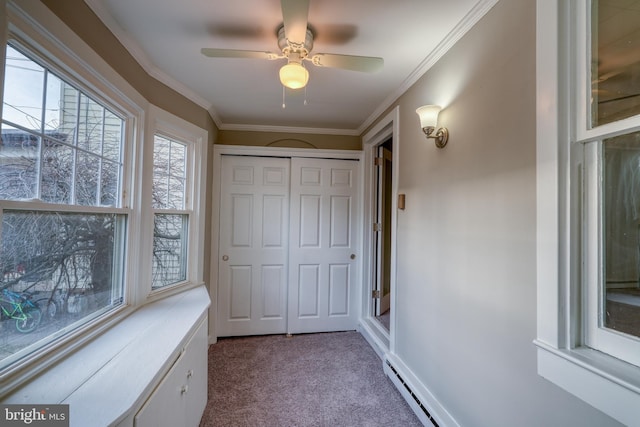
[576, 0, 640, 367]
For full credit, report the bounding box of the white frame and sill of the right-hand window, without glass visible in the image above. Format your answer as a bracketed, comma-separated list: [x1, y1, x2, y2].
[535, 0, 640, 426]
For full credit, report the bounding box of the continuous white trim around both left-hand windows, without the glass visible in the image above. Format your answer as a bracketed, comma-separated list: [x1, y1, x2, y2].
[0, 0, 208, 396]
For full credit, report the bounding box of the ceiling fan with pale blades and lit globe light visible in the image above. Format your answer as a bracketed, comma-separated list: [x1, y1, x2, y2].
[200, 0, 384, 89]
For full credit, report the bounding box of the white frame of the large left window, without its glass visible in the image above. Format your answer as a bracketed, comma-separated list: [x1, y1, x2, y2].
[0, 20, 143, 395]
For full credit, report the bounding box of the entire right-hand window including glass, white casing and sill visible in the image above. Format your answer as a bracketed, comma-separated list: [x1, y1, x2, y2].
[536, 0, 640, 425]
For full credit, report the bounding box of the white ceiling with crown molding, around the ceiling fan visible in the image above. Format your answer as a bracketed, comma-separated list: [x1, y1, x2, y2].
[85, 0, 497, 135]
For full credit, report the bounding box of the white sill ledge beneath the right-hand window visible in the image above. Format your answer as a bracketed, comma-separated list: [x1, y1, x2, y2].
[535, 341, 640, 426]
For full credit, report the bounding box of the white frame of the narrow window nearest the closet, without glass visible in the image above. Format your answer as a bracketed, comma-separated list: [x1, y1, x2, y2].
[143, 105, 208, 300]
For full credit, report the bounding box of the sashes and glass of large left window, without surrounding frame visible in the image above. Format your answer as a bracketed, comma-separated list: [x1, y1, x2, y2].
[0, 43, 129, 370]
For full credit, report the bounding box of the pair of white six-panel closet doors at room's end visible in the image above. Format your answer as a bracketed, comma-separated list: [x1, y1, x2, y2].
[216, 156, 359, 336]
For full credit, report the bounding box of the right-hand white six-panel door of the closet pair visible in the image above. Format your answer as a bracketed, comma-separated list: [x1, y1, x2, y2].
[288, 158, 360, 333]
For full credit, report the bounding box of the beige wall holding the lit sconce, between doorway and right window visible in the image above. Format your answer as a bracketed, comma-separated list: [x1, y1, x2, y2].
[362, 0, 618, 427]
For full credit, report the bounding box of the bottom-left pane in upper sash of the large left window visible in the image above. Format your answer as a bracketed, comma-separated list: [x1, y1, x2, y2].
[0, 124, 40, 200]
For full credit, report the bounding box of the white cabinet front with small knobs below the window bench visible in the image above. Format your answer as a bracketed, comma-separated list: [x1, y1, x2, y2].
[134, 322, 207, 427]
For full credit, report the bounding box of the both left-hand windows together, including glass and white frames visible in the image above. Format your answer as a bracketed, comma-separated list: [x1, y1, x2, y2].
[0, 0, 208, 402]
